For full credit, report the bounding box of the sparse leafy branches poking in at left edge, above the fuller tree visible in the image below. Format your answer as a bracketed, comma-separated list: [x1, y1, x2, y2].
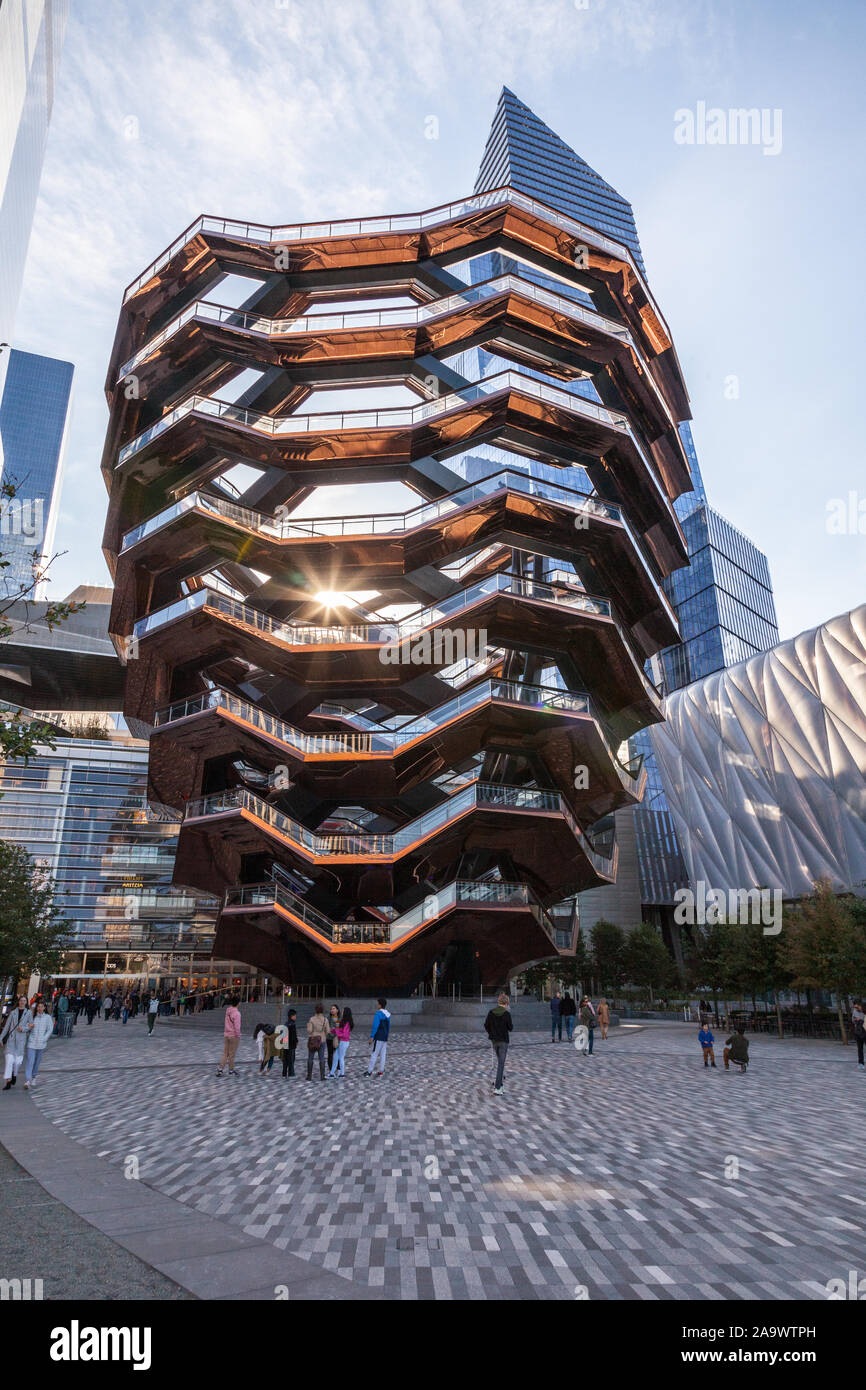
[0, 475, 85, 763]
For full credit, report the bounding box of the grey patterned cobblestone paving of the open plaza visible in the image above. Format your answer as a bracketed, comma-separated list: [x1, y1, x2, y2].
[18, 1020, 866, 1300]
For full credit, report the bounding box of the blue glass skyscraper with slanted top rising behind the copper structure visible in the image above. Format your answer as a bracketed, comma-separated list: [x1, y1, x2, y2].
[475, 88, 778, 926]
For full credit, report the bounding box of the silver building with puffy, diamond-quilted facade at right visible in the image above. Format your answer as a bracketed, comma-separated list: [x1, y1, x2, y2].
[651, 605, 866, 898]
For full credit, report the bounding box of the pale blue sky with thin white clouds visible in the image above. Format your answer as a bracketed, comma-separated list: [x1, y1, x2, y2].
[15, 0, 866, 638]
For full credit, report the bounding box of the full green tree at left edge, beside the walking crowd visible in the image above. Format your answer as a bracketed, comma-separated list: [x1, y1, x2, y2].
[0, 840, 65, 983]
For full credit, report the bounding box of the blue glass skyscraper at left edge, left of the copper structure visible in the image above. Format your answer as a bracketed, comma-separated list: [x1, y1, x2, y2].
[0, 350, 74, 598]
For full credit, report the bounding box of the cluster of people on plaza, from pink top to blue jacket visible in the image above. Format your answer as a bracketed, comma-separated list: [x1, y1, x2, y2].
[217, 997, 391, 1081]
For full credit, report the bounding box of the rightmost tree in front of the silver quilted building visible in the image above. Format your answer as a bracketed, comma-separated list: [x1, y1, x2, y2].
[780, 878, 866, 1043]
